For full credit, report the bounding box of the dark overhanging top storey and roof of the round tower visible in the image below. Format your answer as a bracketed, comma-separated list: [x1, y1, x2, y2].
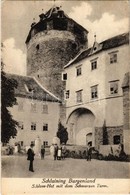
[26, 7, 88, 48]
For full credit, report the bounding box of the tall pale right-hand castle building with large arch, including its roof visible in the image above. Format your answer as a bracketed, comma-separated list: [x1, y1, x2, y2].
[63, 33, 130, 152]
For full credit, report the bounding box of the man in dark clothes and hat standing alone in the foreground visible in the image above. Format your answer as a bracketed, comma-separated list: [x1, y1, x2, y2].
[27, 144, 35, 172]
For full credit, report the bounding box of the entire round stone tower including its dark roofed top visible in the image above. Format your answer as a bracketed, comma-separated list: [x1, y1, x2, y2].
[26, 6, 88, 98]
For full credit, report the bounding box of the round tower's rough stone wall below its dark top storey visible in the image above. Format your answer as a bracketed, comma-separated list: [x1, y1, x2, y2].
[27, 31, 79, 98]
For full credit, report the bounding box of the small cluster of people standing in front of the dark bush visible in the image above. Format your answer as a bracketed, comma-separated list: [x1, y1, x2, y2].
[50, 144, 66, 160]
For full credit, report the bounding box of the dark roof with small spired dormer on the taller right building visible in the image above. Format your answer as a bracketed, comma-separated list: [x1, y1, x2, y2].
[64, 33, 129, 68]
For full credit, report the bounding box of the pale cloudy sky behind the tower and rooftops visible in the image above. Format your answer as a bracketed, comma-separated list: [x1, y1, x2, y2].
[1, 0, 130, 75]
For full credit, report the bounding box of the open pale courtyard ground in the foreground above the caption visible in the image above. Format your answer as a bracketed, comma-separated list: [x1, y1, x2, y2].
[2, 155, 130, 178]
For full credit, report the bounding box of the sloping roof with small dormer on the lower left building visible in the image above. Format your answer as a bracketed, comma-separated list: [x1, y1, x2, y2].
[6, 73, 61, 102]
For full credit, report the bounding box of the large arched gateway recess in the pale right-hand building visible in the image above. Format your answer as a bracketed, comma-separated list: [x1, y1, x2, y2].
[67, 108, 95, 145]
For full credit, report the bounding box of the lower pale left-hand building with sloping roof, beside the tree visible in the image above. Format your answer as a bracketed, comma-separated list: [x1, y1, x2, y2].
[7, 74, 61, 147]
